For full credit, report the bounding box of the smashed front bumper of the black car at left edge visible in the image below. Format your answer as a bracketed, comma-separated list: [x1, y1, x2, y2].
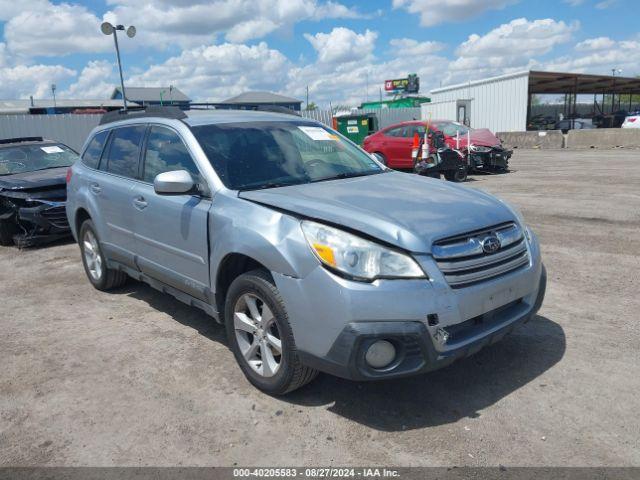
[0, 196, 70, 248]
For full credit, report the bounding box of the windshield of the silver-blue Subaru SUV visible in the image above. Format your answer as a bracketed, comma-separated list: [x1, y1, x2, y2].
[192, 122, 385, 190]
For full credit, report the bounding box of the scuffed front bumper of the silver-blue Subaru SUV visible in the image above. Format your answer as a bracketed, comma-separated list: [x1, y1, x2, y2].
[273, 234, 546, 380]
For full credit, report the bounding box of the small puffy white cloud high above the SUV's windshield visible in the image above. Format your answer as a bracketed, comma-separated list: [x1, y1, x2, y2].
[304, 27, 378, 64]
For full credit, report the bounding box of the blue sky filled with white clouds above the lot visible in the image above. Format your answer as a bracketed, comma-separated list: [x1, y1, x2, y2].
[0, 0, 640, 105]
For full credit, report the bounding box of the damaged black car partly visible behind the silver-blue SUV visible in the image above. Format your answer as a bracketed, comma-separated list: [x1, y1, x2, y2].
[0, 137, 78, 248]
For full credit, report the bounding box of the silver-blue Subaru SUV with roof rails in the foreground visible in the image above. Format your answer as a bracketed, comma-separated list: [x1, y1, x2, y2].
[67, 109, 546, 394]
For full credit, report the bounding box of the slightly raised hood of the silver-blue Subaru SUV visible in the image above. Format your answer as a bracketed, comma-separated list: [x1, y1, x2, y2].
[239, 172, 516, 253]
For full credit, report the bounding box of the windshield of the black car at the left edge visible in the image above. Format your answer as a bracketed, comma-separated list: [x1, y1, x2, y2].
[0, 143, 78, 175]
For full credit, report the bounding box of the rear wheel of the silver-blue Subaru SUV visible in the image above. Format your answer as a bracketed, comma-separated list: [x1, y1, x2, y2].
[78, 220, 127, 291]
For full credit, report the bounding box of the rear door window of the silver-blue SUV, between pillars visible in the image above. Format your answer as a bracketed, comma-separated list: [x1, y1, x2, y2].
[101, 125, 146, 178]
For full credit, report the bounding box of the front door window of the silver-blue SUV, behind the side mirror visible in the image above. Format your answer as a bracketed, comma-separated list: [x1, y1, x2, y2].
[142, 125, 200, 183]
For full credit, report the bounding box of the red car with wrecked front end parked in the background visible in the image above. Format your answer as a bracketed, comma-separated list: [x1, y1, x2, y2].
[362, 120, 511, 170]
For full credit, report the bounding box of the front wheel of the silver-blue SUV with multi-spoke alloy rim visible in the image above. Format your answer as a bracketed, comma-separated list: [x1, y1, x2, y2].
[225, 270, 318, 395]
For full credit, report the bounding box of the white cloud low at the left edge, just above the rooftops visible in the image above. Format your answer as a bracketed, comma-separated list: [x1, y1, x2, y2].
[0, 65, 76, 98]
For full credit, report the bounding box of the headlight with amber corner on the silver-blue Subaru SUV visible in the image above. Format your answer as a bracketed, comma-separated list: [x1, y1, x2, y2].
[301, 220, 426, 281]
